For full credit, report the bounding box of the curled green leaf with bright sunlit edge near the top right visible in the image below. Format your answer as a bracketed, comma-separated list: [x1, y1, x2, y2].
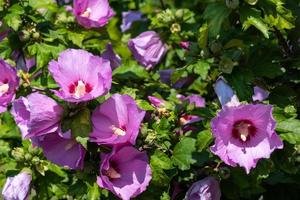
[240, 7, 269, 38]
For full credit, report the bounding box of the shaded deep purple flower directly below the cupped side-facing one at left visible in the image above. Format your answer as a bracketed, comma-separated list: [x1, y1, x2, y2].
[32, 130, 86, 169]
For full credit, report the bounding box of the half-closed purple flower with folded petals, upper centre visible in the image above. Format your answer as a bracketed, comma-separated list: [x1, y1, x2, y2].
[128, 31, 167, 69]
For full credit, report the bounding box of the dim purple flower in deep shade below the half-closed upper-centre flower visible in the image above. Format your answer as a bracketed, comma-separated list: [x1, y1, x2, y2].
[159, 69, 193, 89]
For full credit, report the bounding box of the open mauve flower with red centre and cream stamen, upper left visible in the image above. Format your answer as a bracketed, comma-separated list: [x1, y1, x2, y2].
[49, 49, 112, 103]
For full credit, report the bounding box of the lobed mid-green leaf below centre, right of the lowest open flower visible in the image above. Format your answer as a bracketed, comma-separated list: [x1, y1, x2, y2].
[171, 137, 196, 170]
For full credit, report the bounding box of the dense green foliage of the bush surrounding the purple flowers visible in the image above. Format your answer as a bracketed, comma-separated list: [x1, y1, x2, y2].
[0, 0, 300, 200]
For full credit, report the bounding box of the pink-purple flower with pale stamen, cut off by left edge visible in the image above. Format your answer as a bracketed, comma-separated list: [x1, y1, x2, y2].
[0, 59, 19, 113]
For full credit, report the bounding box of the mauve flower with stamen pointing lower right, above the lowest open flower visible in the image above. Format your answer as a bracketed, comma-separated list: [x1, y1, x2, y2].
[90, 94, 145, 145]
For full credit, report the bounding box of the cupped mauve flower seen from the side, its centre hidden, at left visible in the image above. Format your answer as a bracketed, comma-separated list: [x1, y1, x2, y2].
[11, 93, 63, 138]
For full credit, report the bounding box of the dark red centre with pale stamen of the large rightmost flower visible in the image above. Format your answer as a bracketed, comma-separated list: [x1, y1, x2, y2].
[232, 119, 257, 142]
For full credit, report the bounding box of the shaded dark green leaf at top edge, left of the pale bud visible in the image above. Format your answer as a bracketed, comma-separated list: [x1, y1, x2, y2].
[203, 2, 231, 37]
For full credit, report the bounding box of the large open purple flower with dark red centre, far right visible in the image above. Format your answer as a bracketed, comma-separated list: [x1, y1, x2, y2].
[211, 104, 283, 173]
